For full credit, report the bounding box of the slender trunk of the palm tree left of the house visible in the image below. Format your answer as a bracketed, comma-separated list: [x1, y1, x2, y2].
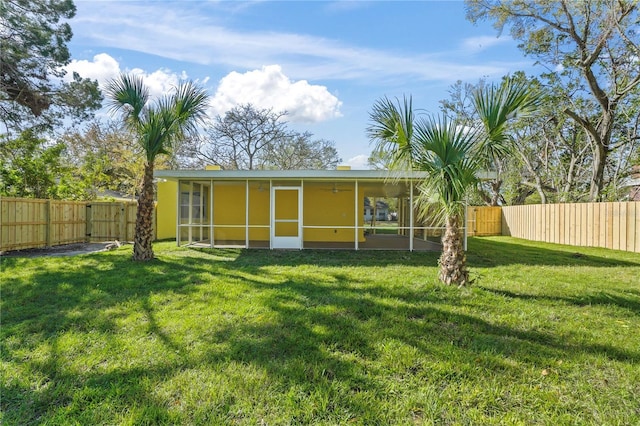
[133, 163, 155, 261]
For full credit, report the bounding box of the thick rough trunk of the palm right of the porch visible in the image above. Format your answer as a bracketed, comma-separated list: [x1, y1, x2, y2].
[438, 216, 470, 287]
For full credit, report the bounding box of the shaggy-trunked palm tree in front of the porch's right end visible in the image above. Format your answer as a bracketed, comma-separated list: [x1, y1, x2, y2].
[367, 79, 539, 286]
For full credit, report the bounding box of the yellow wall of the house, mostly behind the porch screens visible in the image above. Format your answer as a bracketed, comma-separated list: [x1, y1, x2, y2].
[157, 181, 365, 242]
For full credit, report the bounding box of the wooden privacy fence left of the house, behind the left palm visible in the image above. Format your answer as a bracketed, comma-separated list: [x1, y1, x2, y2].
[0, 197, 144, 252]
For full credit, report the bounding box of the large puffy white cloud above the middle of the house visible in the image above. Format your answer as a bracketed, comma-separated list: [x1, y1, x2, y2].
[211, 65, 342, 123]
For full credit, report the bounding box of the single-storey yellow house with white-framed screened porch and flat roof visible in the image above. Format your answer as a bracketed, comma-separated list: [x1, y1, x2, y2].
[155, 168, 492, 250]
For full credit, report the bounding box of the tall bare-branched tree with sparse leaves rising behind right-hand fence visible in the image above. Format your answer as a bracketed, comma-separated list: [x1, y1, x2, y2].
[466, 0, 640, 201]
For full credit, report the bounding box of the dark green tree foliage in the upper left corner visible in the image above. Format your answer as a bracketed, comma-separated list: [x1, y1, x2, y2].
[0, 0, 102, 133]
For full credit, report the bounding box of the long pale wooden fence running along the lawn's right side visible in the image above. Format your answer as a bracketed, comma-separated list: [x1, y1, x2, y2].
[502, 201, 640, 252]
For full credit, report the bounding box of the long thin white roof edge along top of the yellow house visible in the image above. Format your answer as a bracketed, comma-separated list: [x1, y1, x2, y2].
[153, 170, 496, 180]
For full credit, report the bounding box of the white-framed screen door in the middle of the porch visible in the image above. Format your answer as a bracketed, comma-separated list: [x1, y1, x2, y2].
[271, 186, 302, 249]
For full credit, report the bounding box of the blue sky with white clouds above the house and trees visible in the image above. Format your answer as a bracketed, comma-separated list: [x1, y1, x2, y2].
[68, 0, 534, 168]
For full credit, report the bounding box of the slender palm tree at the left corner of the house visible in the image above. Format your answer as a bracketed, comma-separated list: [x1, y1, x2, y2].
[107, 74, 209, 261]
